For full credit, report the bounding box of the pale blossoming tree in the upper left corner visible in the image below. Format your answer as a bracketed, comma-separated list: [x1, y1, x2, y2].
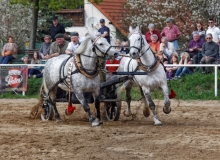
[0, 0, 32, 49]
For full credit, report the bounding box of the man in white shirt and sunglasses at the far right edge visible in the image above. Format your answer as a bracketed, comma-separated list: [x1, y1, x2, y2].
[206, 18, 220, 44]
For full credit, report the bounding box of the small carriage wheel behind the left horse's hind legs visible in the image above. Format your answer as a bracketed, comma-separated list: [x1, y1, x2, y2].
[41, 102, 54, 121]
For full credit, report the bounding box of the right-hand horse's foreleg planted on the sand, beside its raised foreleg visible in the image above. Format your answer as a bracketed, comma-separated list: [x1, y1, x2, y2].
[143, 90, 162, 126]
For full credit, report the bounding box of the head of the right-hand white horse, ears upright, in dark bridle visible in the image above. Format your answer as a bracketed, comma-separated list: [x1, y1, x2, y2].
[128, 26, 146, 59]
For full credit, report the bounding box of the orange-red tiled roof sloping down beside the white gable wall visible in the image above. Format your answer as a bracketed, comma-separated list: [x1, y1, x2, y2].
[91, 0, 128, 36]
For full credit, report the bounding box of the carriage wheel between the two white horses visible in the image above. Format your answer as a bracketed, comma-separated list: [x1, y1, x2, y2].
[105, 88, 121, 121]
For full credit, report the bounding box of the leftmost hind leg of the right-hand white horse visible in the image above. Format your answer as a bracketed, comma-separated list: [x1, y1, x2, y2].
[123, 81, 132, 117]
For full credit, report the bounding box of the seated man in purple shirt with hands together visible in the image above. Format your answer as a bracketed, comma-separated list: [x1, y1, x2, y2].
[187, 32, 204, 64]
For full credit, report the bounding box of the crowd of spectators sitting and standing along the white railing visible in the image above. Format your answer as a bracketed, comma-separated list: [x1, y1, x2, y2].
[0, 17, 220, 80]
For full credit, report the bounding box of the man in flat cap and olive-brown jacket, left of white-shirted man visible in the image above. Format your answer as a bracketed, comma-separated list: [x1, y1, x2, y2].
[49, 33, 69, 58]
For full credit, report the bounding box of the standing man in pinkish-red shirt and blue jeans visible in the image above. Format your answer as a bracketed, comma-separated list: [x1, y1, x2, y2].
[161, 18, 181, 50]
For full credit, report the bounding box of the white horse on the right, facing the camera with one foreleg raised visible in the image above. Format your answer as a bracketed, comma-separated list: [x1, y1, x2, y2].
[117, 27, 171, 126]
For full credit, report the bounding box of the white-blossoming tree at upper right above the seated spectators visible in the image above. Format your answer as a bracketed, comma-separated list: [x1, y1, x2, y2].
[122, 0, 220, 48]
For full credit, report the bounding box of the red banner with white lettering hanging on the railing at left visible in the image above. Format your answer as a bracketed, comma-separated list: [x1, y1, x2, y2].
[0, 66, 28, 91]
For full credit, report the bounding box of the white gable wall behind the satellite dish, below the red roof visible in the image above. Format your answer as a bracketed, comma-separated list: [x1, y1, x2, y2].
[65, 0, 116, 45]
